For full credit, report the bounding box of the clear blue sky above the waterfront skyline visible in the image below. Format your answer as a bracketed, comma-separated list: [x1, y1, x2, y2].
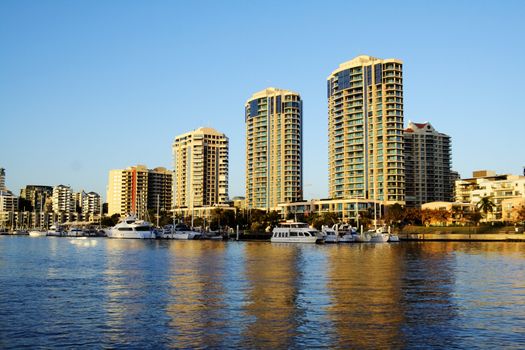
[0, 0, 525, 198]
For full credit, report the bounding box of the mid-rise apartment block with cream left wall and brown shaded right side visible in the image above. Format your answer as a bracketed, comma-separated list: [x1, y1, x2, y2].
[107, 165, 173, 217]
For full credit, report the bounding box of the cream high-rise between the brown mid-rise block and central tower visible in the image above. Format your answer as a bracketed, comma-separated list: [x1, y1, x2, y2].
[172, 128, 228, 208]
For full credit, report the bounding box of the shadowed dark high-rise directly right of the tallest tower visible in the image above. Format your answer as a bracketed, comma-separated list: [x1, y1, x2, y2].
[404, 122, 453, 207]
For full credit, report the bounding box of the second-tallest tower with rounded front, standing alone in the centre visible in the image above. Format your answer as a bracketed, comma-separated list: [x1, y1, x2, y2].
[245, 87, 303, 210]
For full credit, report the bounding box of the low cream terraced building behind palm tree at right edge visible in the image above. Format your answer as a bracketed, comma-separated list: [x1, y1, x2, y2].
[455, 170, 525, 221]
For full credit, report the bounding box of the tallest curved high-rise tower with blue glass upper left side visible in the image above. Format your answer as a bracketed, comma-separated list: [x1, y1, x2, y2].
[327, 56, 405, 205]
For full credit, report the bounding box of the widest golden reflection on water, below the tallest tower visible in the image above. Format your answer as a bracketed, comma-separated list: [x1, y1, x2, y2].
[327, 244, 404, 348]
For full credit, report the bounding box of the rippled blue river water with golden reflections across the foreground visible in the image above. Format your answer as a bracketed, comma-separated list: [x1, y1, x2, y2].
[0, 236, 525, 349]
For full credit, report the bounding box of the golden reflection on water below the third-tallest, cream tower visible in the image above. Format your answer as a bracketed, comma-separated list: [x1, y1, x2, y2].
[166, 241, 227, 348]
